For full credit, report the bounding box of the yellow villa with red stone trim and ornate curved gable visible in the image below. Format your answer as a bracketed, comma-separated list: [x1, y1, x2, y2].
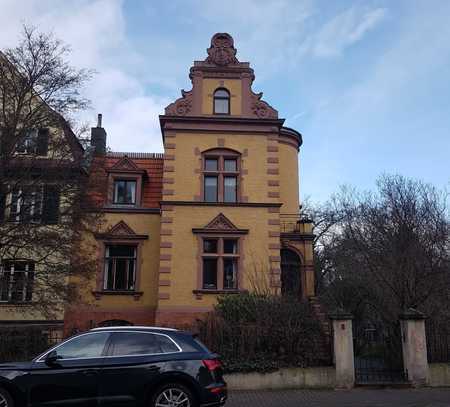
[65, 34, 314, 331]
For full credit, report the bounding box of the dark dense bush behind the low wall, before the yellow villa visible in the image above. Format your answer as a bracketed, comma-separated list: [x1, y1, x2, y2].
[197, 293, 331, 373]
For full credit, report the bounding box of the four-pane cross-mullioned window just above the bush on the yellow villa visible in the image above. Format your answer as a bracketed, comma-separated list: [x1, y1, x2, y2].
[202, 237, 239, 290]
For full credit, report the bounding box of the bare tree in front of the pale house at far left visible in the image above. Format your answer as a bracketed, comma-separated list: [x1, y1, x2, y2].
[0, 27, 100, 317]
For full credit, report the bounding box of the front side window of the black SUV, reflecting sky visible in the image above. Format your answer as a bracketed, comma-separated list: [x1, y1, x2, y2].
[51, 332, 109, 359]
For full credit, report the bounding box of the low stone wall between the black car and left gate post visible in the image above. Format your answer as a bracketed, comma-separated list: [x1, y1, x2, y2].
[225, 366, 336, 390]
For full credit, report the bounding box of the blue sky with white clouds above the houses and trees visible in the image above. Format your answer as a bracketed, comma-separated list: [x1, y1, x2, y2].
[0, 0, 450, 202]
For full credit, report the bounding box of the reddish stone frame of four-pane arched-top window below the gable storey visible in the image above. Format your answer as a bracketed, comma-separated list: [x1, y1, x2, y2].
[200, 148, 242, 203]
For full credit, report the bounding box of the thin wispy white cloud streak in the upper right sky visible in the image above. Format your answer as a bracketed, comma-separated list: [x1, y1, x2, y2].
[311, 6, 387, 58]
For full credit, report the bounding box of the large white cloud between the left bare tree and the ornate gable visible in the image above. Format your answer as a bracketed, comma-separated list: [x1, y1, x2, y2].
[0, 0, 169, 151]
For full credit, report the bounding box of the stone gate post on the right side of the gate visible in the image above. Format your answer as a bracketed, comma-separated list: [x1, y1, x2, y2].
[400, 309, 429, 387]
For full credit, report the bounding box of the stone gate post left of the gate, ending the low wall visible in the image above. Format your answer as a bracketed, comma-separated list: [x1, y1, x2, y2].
[330, 311, 355, 389]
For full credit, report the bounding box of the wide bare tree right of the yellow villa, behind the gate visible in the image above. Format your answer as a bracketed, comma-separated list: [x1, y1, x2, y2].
[317, 175, 450, 321]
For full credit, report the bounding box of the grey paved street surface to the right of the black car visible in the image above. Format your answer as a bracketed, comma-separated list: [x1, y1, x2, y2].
[226, 389, 450, 407]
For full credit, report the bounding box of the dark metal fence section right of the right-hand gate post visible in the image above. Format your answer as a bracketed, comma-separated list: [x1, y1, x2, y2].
[426, 321, 450, 363]
